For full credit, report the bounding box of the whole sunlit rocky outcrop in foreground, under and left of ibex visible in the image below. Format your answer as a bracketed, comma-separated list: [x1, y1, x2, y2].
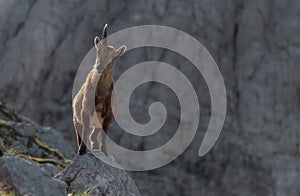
[0, 101, 140, 196]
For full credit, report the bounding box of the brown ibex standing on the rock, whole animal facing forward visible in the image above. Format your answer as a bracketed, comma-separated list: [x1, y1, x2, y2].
[73, 25, 126, 155]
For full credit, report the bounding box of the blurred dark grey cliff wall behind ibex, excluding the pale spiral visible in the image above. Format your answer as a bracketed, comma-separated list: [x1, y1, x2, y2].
[0, 0, 300, 195]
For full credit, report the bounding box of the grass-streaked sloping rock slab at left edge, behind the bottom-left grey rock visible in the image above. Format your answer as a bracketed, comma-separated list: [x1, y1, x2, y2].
[0, 101, 75, 170]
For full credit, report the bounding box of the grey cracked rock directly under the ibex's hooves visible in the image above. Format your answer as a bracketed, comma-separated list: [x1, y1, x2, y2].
[57, 154, 140, 196]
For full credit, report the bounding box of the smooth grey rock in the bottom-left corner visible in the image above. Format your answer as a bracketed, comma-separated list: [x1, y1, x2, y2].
[0, 156, 66, 196]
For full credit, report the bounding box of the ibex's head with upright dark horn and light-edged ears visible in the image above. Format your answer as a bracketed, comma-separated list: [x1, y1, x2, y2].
[94, 24, 126, 73]
